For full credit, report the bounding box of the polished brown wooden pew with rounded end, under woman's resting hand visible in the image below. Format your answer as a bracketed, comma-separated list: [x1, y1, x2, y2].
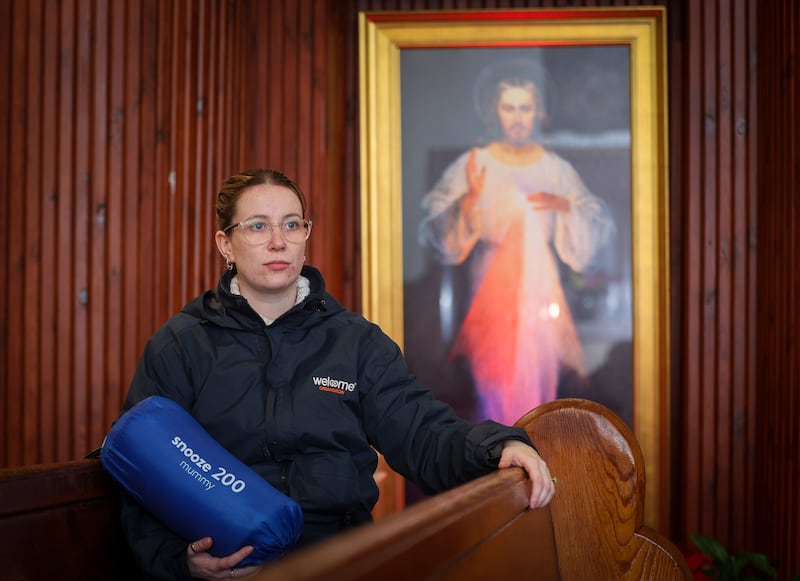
[254, 399, 692, 581]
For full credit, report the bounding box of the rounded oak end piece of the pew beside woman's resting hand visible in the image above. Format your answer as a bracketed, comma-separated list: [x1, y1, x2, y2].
[516, 399, 692, 581]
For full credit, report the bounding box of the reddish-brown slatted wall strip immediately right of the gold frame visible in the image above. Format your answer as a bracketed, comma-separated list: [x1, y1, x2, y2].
[672, 0, 756, 548]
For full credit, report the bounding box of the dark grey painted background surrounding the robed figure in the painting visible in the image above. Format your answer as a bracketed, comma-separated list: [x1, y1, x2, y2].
[400, 46, 633, 454]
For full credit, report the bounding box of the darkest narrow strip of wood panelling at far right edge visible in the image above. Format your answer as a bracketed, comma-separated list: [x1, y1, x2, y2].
[754, 0, 800, 579]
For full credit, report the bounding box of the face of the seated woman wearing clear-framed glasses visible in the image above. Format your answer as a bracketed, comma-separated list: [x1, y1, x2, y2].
[216, 184, 306, 298]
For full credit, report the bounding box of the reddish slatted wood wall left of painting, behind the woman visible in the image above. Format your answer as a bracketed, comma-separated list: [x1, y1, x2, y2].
[0, 0, 350, 466]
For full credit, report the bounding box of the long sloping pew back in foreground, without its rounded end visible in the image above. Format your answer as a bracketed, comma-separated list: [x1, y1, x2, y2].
[255, 468, 559, 581]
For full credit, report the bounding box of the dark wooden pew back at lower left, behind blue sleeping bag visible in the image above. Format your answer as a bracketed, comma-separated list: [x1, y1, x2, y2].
[0, 460, 136, 581]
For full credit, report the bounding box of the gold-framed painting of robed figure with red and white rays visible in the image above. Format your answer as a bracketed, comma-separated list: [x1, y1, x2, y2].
[359, 8, 670, 528]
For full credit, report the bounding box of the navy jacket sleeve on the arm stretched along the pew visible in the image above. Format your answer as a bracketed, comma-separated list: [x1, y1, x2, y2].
[354, 328, 533, 494]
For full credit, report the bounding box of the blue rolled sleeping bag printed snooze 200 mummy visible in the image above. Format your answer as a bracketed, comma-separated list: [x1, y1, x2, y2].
[100, 396, 303, 566]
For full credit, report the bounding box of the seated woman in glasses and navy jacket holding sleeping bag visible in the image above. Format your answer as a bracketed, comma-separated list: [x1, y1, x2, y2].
[122, 170, 554, 579]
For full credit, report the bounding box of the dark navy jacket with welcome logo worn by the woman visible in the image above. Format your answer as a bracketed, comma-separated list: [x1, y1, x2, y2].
[122, 266, 529, 579]
